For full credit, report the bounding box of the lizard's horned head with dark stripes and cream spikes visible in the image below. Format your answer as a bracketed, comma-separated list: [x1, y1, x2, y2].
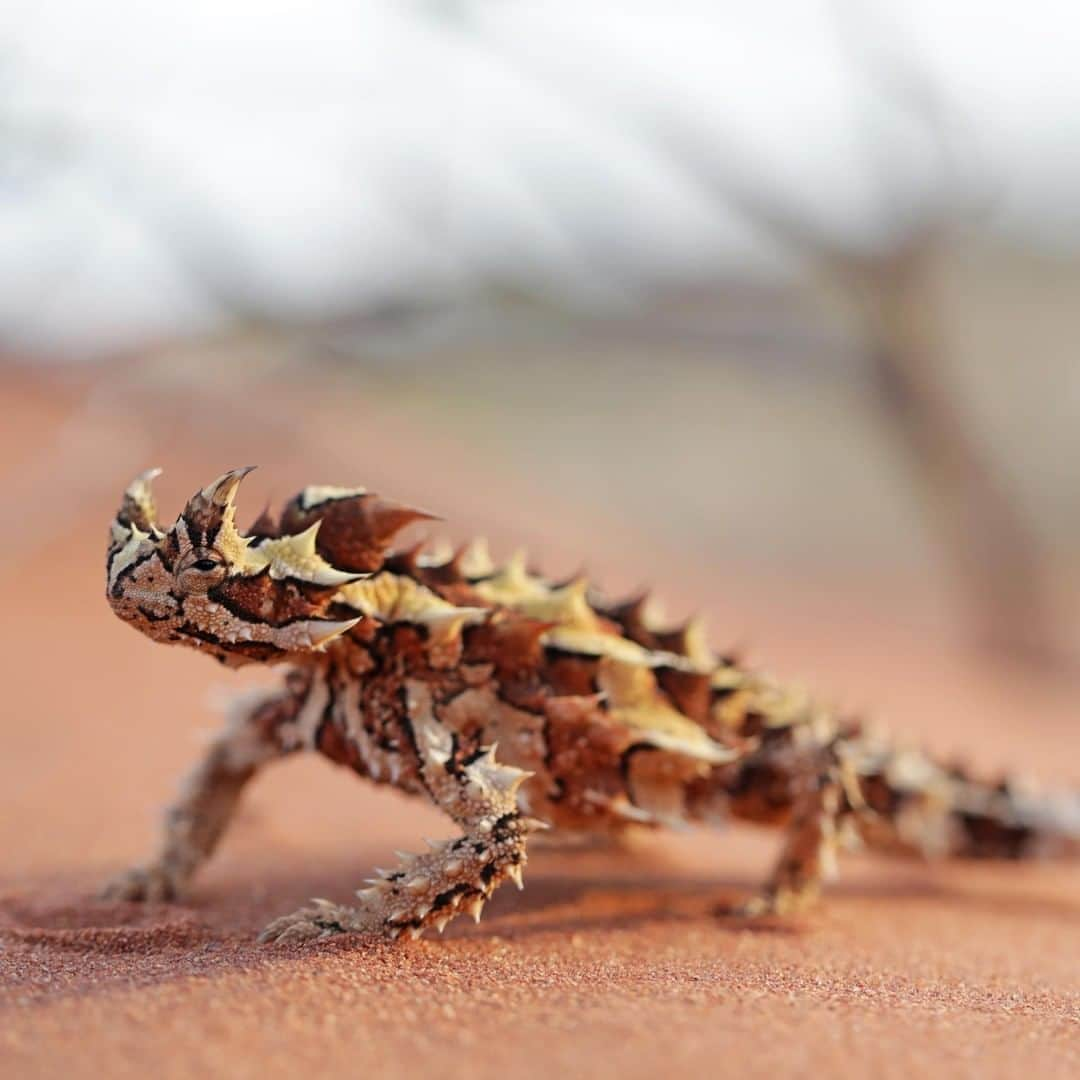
[107, 468, 366, 666]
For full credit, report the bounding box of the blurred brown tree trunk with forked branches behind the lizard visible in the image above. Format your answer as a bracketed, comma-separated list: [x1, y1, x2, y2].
[609, 0, 1062, 665]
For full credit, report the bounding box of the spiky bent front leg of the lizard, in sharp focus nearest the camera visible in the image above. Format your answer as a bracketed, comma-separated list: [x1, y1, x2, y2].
[259, 683, 548, 942]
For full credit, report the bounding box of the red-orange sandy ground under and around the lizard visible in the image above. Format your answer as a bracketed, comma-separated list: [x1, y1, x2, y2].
[0, 367, 1080, 1080]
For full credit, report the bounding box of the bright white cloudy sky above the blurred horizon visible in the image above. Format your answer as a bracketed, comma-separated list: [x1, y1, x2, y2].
[0, 0, 1080, 353]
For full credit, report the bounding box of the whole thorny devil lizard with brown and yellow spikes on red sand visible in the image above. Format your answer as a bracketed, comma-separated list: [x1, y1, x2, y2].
[106, 469, 1080, 941]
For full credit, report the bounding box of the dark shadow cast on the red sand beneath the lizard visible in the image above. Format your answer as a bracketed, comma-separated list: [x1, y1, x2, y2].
[6, 852, 1080, 993]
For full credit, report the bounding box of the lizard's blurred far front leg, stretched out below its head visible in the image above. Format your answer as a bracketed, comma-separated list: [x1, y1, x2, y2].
[102, 677, 310, 901]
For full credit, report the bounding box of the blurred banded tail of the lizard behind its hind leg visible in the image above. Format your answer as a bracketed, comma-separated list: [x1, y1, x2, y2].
[848, 752, 1080, 860]
